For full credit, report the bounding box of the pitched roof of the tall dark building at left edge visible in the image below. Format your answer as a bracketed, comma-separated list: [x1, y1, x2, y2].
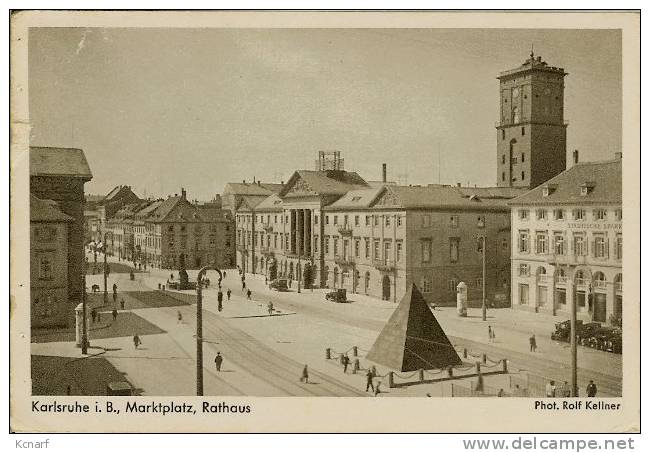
[29, 146, 93, 180]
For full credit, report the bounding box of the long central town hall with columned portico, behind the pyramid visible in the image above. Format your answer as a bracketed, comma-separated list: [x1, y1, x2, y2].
[236, 159, 523, 305]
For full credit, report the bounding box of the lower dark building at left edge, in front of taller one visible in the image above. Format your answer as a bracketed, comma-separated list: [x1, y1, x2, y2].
[29, 195, 72, 327]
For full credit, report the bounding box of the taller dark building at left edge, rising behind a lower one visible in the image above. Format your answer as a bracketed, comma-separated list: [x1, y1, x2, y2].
[29, 147, 92, 326]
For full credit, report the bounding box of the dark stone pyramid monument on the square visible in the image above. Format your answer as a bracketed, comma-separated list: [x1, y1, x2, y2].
[366, 284, 463, 371]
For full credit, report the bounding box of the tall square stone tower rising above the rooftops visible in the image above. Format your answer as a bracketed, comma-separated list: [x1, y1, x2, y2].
[496, 52, 567, 188]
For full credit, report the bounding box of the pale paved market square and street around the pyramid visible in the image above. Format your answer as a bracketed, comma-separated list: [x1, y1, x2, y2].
[32, 251, 621, 396]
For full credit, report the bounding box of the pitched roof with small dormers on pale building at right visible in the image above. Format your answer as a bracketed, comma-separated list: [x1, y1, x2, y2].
[508, 159, 623, 205]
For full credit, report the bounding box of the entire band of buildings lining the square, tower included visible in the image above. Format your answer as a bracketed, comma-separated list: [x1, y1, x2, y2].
[30, 54, 623, 325]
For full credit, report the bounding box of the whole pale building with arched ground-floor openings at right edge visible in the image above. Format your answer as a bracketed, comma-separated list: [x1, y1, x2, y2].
[510, 156, 623, 325]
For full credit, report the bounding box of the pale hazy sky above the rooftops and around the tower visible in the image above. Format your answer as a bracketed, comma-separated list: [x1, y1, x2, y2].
[29, 28, 621, 200]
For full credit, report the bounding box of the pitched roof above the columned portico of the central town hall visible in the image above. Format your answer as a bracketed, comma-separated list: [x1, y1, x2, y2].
[279, 170, 370, 198]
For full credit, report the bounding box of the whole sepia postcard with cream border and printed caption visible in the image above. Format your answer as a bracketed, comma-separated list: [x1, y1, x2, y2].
[10, 11, 641, 433]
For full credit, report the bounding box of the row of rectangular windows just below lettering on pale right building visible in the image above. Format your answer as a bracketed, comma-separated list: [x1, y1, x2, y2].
[517, 230, 623, 260]
